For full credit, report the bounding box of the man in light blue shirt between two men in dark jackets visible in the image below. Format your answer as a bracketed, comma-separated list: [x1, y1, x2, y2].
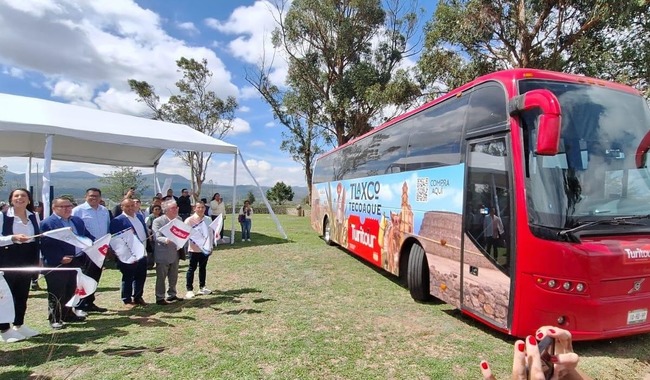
[72, 187, 111, 313]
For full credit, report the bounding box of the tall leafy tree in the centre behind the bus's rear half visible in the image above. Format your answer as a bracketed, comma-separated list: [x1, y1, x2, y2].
[268, 0, 419, 145]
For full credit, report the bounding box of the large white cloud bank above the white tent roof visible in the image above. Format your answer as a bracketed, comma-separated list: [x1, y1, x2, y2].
[0, 0, 238, 116]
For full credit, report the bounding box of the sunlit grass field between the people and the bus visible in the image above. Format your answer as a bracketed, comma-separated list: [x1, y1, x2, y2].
[0, 215, 650, 379]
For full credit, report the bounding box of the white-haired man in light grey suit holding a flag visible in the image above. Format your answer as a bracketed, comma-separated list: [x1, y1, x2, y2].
[151, 198, 182, 305]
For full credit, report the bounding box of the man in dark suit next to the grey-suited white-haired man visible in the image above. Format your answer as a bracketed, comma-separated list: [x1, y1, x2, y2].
[109, 198, 147, 307]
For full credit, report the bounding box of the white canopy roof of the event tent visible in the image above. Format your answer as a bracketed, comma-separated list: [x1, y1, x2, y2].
[0, 94, 237, 167]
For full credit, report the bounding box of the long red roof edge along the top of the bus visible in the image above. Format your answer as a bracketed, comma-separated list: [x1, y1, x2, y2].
[319, 69, 640, 159]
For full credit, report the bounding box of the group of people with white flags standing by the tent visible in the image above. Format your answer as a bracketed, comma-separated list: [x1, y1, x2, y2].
[0, 188, 246, 343]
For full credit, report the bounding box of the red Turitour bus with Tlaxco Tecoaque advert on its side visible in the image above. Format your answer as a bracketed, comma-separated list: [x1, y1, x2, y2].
[311, 69, 650, 340]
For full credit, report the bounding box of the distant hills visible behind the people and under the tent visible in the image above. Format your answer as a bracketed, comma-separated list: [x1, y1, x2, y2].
[0, 169, 307, 203]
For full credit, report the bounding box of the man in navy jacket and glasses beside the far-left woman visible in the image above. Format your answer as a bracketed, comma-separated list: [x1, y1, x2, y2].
[41, 197, 95, 330]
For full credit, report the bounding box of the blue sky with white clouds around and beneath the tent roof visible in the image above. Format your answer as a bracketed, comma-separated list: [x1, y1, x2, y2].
[0, 0, 431, 186]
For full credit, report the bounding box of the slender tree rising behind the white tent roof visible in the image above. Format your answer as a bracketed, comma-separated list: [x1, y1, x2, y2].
[129, 57, 238, 200]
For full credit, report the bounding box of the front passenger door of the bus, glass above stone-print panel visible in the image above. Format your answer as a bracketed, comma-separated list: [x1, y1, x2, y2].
[461, 135, 514, 329]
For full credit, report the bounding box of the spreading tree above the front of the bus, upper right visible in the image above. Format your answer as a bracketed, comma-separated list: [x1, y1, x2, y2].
[418, 0, 650, 97]
